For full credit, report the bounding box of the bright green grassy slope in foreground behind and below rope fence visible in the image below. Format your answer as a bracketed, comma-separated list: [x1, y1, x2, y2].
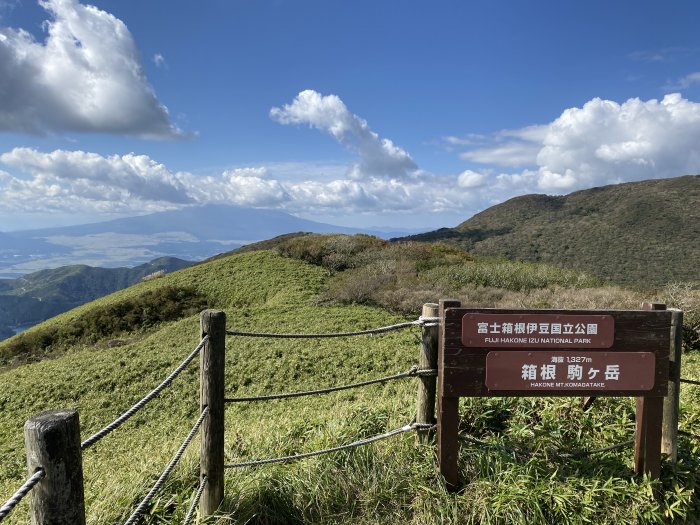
[0, 244, 700, 524]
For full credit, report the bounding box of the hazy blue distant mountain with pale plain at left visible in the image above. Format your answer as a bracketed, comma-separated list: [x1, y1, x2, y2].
[0, 205, 406, 277]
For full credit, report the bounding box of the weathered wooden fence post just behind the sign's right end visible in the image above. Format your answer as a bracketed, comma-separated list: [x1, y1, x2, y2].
[661, 309, 683, 463]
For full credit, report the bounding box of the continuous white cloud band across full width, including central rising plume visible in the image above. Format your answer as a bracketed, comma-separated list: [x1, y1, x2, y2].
[0, 90, 700, 226]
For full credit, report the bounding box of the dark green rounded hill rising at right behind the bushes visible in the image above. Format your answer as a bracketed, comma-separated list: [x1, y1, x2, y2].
[400, 175, 700, 288]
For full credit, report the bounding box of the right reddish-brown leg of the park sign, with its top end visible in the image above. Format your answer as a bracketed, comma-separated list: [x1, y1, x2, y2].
[634, 302, 666, 479]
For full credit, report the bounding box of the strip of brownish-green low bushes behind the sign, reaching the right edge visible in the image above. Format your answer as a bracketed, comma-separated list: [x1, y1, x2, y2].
[277, 234, 700, 338]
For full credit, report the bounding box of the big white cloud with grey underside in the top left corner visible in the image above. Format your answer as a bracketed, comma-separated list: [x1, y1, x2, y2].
[0, 0, 183, 137]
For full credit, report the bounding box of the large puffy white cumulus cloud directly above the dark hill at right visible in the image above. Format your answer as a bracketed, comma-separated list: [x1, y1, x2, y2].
[461, 93, 700, 195]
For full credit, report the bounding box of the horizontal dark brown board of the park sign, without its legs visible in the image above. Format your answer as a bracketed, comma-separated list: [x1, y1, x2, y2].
[438, 308, 671, 397]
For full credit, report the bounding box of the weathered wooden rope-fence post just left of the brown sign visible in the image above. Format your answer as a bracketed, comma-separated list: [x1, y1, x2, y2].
[416, 303, 439, 444]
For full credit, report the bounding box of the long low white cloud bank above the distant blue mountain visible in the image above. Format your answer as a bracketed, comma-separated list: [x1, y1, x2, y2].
[0, 144, 478, 218]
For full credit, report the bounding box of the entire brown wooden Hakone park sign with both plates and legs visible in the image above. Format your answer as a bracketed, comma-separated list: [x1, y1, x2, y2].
[437, 300, 672, 490]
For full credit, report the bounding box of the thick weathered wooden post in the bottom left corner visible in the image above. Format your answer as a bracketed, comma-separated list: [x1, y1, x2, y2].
[24, 410, 85, 525]
